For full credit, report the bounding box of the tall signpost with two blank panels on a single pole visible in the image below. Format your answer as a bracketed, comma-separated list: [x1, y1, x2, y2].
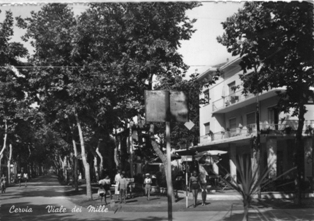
[145, 91, 188, 221]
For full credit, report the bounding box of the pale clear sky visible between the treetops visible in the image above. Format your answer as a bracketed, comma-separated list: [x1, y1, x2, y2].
[0, 0, 244, 75]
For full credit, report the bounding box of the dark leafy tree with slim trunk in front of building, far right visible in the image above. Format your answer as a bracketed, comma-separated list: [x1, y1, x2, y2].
[217, 2, 314, 203]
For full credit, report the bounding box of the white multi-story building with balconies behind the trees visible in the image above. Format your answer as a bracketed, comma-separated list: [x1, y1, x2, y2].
[195, 58, 314, 188]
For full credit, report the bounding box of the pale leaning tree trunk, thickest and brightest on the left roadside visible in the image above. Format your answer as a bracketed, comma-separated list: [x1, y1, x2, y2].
[74, 113, 93, 199]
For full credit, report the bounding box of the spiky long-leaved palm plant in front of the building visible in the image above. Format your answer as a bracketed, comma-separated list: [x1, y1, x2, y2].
[217, 155, 296, 221]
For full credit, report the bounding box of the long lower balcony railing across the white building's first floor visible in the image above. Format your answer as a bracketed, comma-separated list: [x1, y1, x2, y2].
[199, 120, 314, 143]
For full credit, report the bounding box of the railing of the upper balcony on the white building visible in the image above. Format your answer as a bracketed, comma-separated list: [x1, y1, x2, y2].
[213, 89, 254, 111]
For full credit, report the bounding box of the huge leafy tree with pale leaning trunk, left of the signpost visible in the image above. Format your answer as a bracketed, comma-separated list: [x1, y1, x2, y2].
[12, 2, 199, 198]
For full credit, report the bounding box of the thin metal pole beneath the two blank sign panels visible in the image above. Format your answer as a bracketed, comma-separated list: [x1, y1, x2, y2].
[166, 121, 173, 221]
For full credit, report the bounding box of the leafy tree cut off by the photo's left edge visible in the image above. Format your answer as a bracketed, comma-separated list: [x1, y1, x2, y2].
[0, 10, 27, 178]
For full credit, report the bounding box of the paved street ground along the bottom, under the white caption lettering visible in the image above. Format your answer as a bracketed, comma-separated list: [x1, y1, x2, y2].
[0, 176, 314, 221]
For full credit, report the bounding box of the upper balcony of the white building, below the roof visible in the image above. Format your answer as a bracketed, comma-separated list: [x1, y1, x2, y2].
[212, 88, 284, 114]
